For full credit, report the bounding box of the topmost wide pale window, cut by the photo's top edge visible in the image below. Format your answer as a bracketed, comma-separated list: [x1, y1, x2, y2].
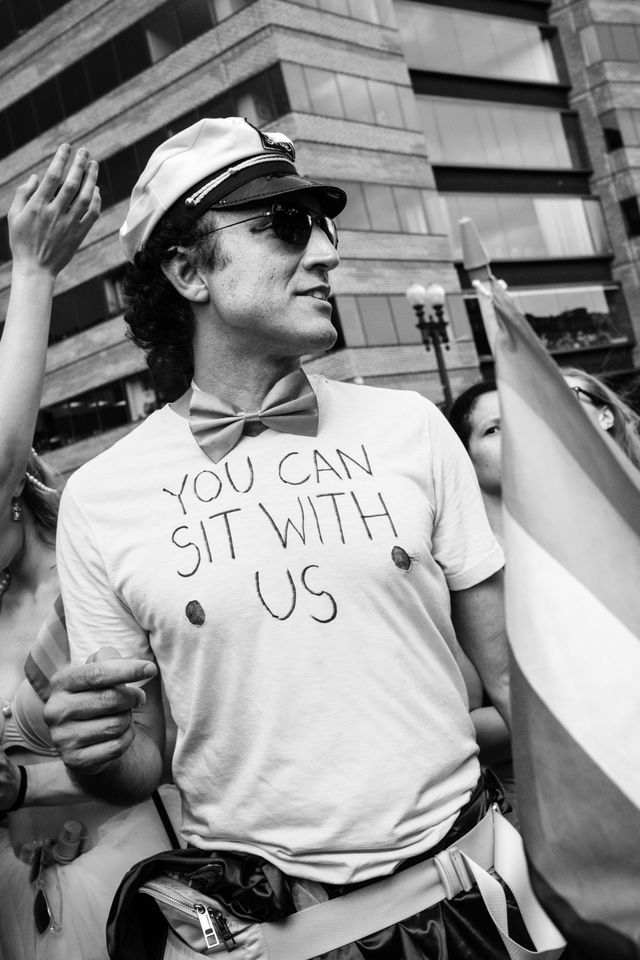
[395, 0, 558, 83]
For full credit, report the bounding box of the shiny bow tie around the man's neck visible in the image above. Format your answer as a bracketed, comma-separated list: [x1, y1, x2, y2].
[189, 369, 318, 463]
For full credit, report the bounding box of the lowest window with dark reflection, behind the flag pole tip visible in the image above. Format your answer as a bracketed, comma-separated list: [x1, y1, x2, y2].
[464, 287, 629, 357]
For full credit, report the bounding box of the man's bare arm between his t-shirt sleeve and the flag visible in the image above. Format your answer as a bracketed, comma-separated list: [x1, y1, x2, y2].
[451, 570, 511, 728]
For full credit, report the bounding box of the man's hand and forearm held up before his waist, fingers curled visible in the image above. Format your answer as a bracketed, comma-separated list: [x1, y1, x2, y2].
[44, 648, 165, 804]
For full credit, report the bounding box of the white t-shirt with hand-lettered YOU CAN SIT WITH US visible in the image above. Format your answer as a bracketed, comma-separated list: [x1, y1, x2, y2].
[58, 377, 503, 883]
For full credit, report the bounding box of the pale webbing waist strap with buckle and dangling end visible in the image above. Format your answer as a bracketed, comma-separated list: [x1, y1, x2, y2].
[261, 807, 565, 960]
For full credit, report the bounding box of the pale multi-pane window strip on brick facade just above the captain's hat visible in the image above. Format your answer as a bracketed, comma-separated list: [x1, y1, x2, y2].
[281, 63, 418, 130]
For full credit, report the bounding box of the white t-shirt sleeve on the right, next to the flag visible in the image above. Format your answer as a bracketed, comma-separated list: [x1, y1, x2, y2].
[428, 396, 504, 590]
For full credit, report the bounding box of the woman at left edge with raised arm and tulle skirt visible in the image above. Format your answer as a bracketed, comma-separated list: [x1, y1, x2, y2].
[0, 144, 180, 960]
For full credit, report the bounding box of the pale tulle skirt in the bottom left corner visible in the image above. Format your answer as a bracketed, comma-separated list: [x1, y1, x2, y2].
[0, 785, 180, 960]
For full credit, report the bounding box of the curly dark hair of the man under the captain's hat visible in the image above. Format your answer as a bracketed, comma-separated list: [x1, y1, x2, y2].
[123, 210, 225, 386]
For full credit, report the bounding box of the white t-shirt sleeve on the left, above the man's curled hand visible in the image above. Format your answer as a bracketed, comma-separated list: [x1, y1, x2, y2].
[57, 484, 153, 663]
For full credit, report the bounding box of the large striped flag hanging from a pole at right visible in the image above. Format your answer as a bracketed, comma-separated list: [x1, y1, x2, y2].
[492, 281, 640, 960]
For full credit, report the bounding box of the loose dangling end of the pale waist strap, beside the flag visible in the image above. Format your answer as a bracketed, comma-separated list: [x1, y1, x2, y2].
[465, 807, 567, 960]
